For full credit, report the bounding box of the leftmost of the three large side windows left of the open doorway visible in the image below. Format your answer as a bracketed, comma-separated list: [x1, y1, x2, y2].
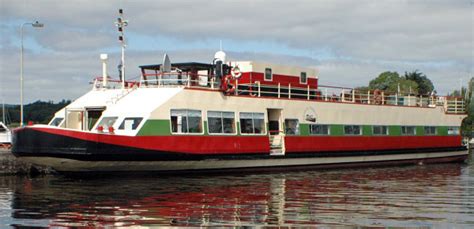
[171, 109, 202, 133]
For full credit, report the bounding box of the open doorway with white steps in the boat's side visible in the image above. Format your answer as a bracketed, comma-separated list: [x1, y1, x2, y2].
[267, 109, 285, 155]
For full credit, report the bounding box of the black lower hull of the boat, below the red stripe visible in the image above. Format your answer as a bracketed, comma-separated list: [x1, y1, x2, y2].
[12, 128, 467, 171]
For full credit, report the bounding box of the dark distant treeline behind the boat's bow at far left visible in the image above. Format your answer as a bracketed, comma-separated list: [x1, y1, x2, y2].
[0, 100, 71, 124]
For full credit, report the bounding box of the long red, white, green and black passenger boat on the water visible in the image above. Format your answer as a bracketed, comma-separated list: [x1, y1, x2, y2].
[12, 10, 468, 172]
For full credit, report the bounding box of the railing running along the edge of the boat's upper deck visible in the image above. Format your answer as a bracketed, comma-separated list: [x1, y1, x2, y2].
[94, 72, 466, 114]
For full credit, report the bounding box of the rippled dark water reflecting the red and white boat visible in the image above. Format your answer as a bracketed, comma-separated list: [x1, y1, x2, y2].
[0, 159, 474, 228]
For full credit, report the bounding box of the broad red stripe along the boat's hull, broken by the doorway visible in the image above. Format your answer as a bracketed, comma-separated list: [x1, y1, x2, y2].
[28, 127, 461, 154]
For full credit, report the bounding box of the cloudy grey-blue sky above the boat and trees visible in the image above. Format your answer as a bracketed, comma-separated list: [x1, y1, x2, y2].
[0, 0, 474, 104]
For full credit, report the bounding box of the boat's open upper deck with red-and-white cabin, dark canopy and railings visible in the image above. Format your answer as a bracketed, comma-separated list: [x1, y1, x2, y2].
[89, 61, 466, 114]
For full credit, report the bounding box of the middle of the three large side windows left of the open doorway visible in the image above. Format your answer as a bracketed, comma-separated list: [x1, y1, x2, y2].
[207, 111, 235, 134]
